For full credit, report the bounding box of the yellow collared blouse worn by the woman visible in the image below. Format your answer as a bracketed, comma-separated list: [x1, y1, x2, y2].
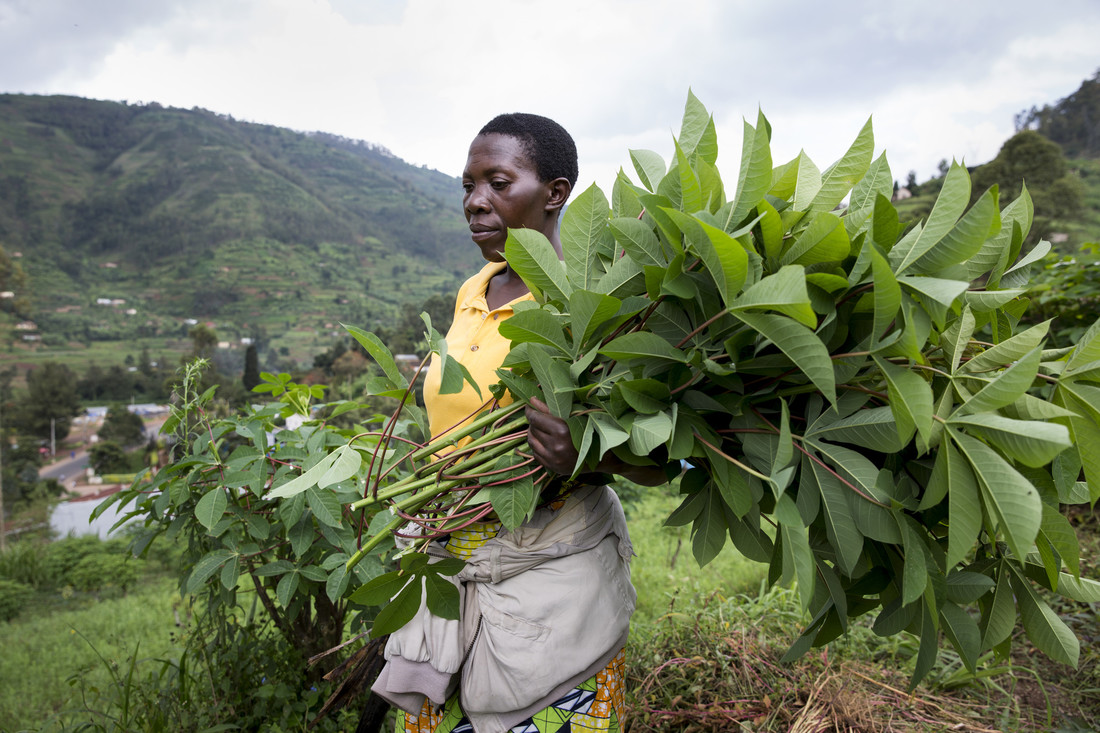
[424, 262, 534, 438]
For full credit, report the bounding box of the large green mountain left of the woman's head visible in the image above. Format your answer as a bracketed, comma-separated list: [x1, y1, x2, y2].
[0, 95, 481, 346]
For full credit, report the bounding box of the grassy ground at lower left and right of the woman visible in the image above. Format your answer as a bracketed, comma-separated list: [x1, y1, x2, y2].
[0, 489, 1100, 733]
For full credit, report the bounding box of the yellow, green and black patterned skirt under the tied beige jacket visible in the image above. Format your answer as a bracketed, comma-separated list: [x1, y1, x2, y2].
[397, 522, 626, 733]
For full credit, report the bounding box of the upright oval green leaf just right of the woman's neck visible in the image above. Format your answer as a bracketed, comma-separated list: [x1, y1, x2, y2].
[563, 184, 615, 295]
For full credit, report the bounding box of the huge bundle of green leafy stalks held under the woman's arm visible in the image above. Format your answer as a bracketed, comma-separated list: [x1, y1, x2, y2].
[266, 95, 1100, 685]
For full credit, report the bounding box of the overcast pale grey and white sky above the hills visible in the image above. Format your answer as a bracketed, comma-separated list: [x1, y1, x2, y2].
[0, 0, 1100, 192]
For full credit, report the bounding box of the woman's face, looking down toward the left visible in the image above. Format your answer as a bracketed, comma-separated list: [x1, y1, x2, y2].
[462, 133, 557, 262]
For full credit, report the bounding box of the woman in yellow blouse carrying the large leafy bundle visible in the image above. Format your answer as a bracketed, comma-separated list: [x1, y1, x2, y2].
[374, 113, 664, 733]
